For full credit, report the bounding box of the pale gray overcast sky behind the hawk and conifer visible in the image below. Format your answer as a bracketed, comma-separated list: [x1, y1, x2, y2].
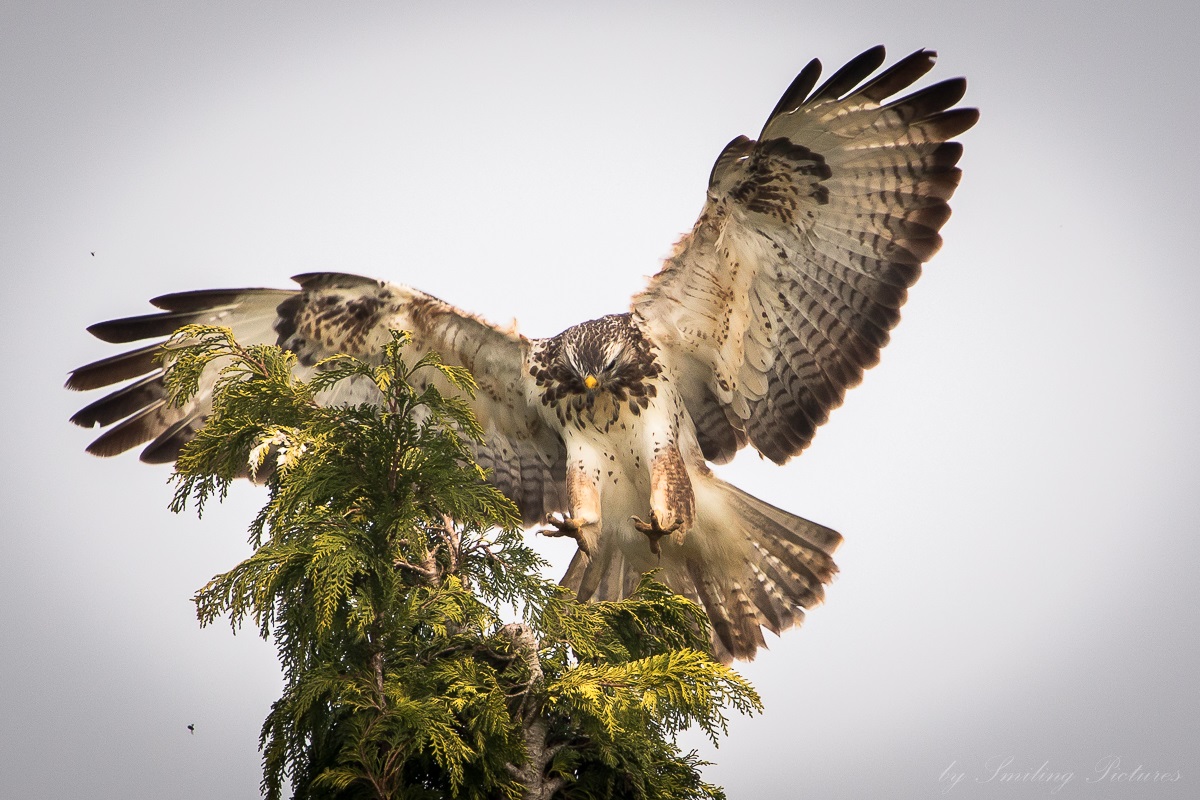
[0, 0, 1200, 800]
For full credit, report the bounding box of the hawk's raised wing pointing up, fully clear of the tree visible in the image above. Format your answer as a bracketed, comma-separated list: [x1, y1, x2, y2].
[632, 47, 978, 463]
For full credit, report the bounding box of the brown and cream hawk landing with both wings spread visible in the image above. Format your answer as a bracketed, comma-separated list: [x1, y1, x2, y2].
[67, 47, 978, 661]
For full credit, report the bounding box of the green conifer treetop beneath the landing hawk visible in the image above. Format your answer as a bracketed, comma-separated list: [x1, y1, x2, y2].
[164, 326, 760, 800]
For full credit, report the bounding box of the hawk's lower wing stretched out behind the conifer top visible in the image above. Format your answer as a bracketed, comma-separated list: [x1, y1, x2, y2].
[67, 273, 566, 524]
